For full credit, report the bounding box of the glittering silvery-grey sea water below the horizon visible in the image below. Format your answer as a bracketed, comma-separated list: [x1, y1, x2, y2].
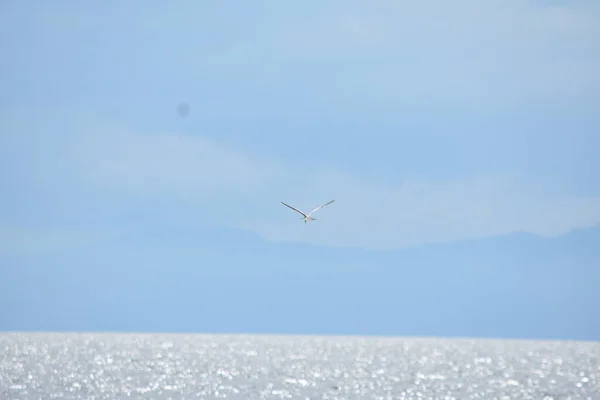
[0, 333, 600, 400]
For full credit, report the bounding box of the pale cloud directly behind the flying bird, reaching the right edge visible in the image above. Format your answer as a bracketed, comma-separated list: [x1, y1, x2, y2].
[242, 169, 600, 249]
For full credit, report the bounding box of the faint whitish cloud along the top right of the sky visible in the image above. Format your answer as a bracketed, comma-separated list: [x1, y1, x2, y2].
[273, 0, 600, 63]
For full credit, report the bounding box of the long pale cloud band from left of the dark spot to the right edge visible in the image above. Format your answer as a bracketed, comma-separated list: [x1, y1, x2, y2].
[54, 123, 600, 252]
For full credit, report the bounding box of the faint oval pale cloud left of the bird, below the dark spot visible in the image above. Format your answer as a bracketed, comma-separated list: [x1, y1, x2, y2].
[73, 130, 277, 198]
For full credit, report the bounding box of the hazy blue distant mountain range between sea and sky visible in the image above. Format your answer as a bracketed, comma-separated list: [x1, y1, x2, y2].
[0, 224, 600, 340]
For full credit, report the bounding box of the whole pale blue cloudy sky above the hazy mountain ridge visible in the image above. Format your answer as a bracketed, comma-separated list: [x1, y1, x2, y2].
[0, 0, 600, 252]
